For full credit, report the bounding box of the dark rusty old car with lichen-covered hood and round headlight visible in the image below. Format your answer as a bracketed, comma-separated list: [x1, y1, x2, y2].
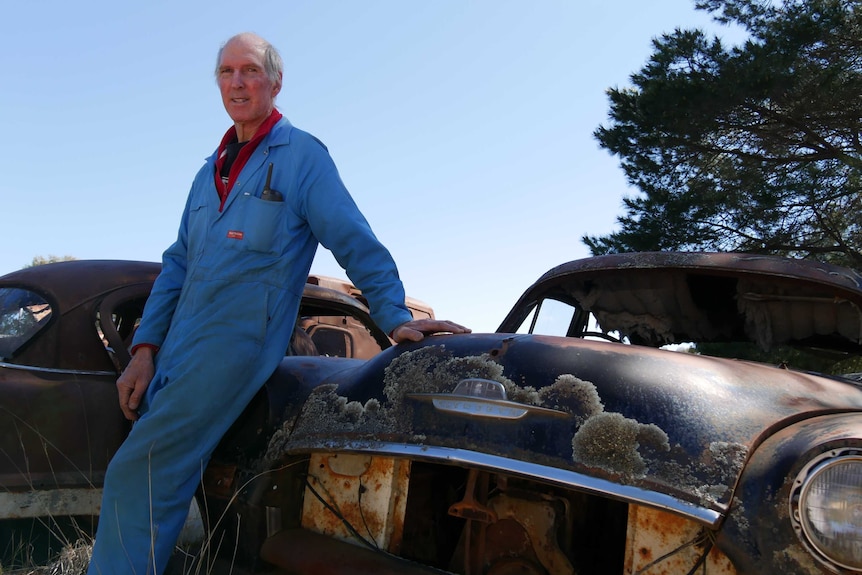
[3, 253, 862, 575]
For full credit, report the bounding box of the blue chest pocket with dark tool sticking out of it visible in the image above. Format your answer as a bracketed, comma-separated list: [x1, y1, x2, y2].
[228, 196, 287, 255]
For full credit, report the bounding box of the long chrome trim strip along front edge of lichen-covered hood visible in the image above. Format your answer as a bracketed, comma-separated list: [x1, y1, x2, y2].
[318, 441, 723, 528]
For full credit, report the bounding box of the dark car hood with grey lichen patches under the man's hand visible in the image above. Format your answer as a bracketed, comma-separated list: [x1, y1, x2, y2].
[269, 334, 862, 523]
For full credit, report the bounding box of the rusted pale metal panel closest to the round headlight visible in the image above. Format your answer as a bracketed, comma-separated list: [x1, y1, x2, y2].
[624, 505, 737, 575]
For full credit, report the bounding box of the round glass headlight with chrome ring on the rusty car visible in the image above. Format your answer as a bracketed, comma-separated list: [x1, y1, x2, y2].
[790, 450, 862, 572]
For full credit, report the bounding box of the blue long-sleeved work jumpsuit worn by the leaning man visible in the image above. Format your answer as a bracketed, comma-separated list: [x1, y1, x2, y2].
[89, 119, 412, 574]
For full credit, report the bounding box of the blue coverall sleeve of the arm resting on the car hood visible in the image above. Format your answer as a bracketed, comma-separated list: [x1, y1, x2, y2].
[295, 136, 413, 333]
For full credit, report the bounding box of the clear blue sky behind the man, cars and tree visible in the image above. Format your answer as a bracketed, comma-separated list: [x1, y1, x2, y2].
[0, 0, 744, 331]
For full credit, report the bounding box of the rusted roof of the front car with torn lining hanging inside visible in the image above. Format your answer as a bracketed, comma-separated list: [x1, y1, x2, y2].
[497, 252, 862, 352]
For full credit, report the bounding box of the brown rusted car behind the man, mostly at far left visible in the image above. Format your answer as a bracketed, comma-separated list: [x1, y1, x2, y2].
[0, 260, 433, 565]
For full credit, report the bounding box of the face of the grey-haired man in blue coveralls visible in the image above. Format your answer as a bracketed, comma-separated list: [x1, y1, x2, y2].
[218, 38, 281, 137]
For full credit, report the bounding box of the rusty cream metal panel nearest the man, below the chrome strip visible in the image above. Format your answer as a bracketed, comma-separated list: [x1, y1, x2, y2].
[302, 453, 410, 553]
